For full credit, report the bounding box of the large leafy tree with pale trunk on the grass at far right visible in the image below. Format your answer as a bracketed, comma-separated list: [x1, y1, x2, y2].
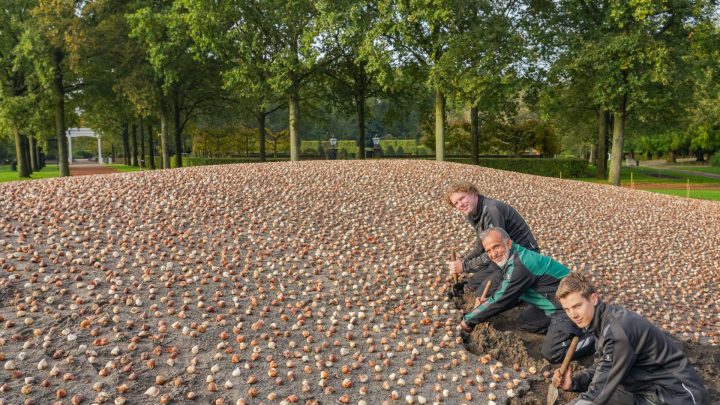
[543, 0, 712, 185]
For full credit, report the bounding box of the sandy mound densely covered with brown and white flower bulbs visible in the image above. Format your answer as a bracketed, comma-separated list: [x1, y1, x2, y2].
[0, 161, 720, 405]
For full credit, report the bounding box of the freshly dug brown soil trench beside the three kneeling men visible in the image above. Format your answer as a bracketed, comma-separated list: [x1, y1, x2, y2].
[454, 292, 720, 405]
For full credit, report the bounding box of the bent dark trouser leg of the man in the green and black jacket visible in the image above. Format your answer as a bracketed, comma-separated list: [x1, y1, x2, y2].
[538, 310, 595, 364]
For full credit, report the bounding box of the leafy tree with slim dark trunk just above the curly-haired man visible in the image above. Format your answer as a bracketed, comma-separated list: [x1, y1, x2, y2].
[437, 0, 528, 164]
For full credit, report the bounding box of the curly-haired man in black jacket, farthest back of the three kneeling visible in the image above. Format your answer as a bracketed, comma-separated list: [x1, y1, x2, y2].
[445, 182, 547, 326]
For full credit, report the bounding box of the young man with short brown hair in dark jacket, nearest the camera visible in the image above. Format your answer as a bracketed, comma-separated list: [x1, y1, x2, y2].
[553, 273, 709, 405]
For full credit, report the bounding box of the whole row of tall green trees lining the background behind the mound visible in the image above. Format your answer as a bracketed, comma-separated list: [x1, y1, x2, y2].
[0, 0, 720, 184]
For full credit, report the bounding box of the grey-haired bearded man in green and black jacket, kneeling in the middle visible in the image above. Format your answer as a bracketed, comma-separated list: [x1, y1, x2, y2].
[460, 228, 593, 363]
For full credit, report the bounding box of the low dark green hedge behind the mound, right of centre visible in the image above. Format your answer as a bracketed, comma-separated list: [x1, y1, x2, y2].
[472, 158, 588, 177]
